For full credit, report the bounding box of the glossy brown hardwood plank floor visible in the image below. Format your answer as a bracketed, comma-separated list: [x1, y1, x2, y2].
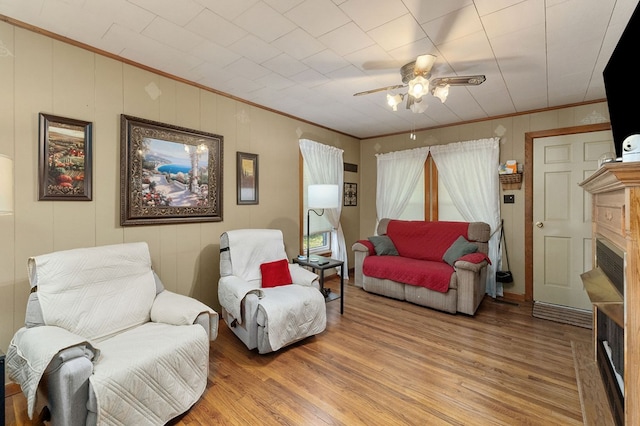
[5, 280, 606, 426]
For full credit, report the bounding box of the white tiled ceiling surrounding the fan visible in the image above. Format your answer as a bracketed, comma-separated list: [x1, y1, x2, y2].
[0, 0, 638, 138]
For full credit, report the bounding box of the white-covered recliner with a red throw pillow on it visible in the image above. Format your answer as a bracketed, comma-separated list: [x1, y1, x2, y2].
[218, 229, 327, 354]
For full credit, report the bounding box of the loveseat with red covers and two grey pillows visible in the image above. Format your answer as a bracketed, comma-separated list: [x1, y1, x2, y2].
[352, 219, 490, 315]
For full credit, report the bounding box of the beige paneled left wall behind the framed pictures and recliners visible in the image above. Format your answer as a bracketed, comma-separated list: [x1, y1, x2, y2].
[0, 22, 359, 352]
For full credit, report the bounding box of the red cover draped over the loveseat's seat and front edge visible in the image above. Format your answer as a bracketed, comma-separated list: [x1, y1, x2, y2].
[362, 256, 454, 293]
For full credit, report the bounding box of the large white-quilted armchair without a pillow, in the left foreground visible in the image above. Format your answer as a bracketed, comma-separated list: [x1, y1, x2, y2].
[6, 243, 218, 426]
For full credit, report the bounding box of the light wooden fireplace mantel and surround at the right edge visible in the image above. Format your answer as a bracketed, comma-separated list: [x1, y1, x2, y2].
[580, 162, 640, 425]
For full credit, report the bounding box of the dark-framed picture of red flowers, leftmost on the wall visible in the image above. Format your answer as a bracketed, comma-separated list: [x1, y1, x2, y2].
[38, 113, 92, 201]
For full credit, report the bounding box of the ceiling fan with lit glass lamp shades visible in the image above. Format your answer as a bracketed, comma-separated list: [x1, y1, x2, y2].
[353, 55, 486, 113]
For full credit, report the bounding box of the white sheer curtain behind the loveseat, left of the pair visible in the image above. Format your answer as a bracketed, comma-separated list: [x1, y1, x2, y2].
[374, 147, 429, 231]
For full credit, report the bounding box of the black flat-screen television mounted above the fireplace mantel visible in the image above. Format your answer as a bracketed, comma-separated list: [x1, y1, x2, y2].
[602, 5, 640, 158]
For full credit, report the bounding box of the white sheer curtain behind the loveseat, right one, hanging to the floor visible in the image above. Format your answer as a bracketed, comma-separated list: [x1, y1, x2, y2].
[430, 138, 503, 297]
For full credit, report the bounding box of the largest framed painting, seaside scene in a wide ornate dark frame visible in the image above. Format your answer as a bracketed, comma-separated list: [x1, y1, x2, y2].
[120, 114, 223, 226]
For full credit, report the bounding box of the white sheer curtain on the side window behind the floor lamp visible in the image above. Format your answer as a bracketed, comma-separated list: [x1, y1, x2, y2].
[299, 139, 349, 280]
